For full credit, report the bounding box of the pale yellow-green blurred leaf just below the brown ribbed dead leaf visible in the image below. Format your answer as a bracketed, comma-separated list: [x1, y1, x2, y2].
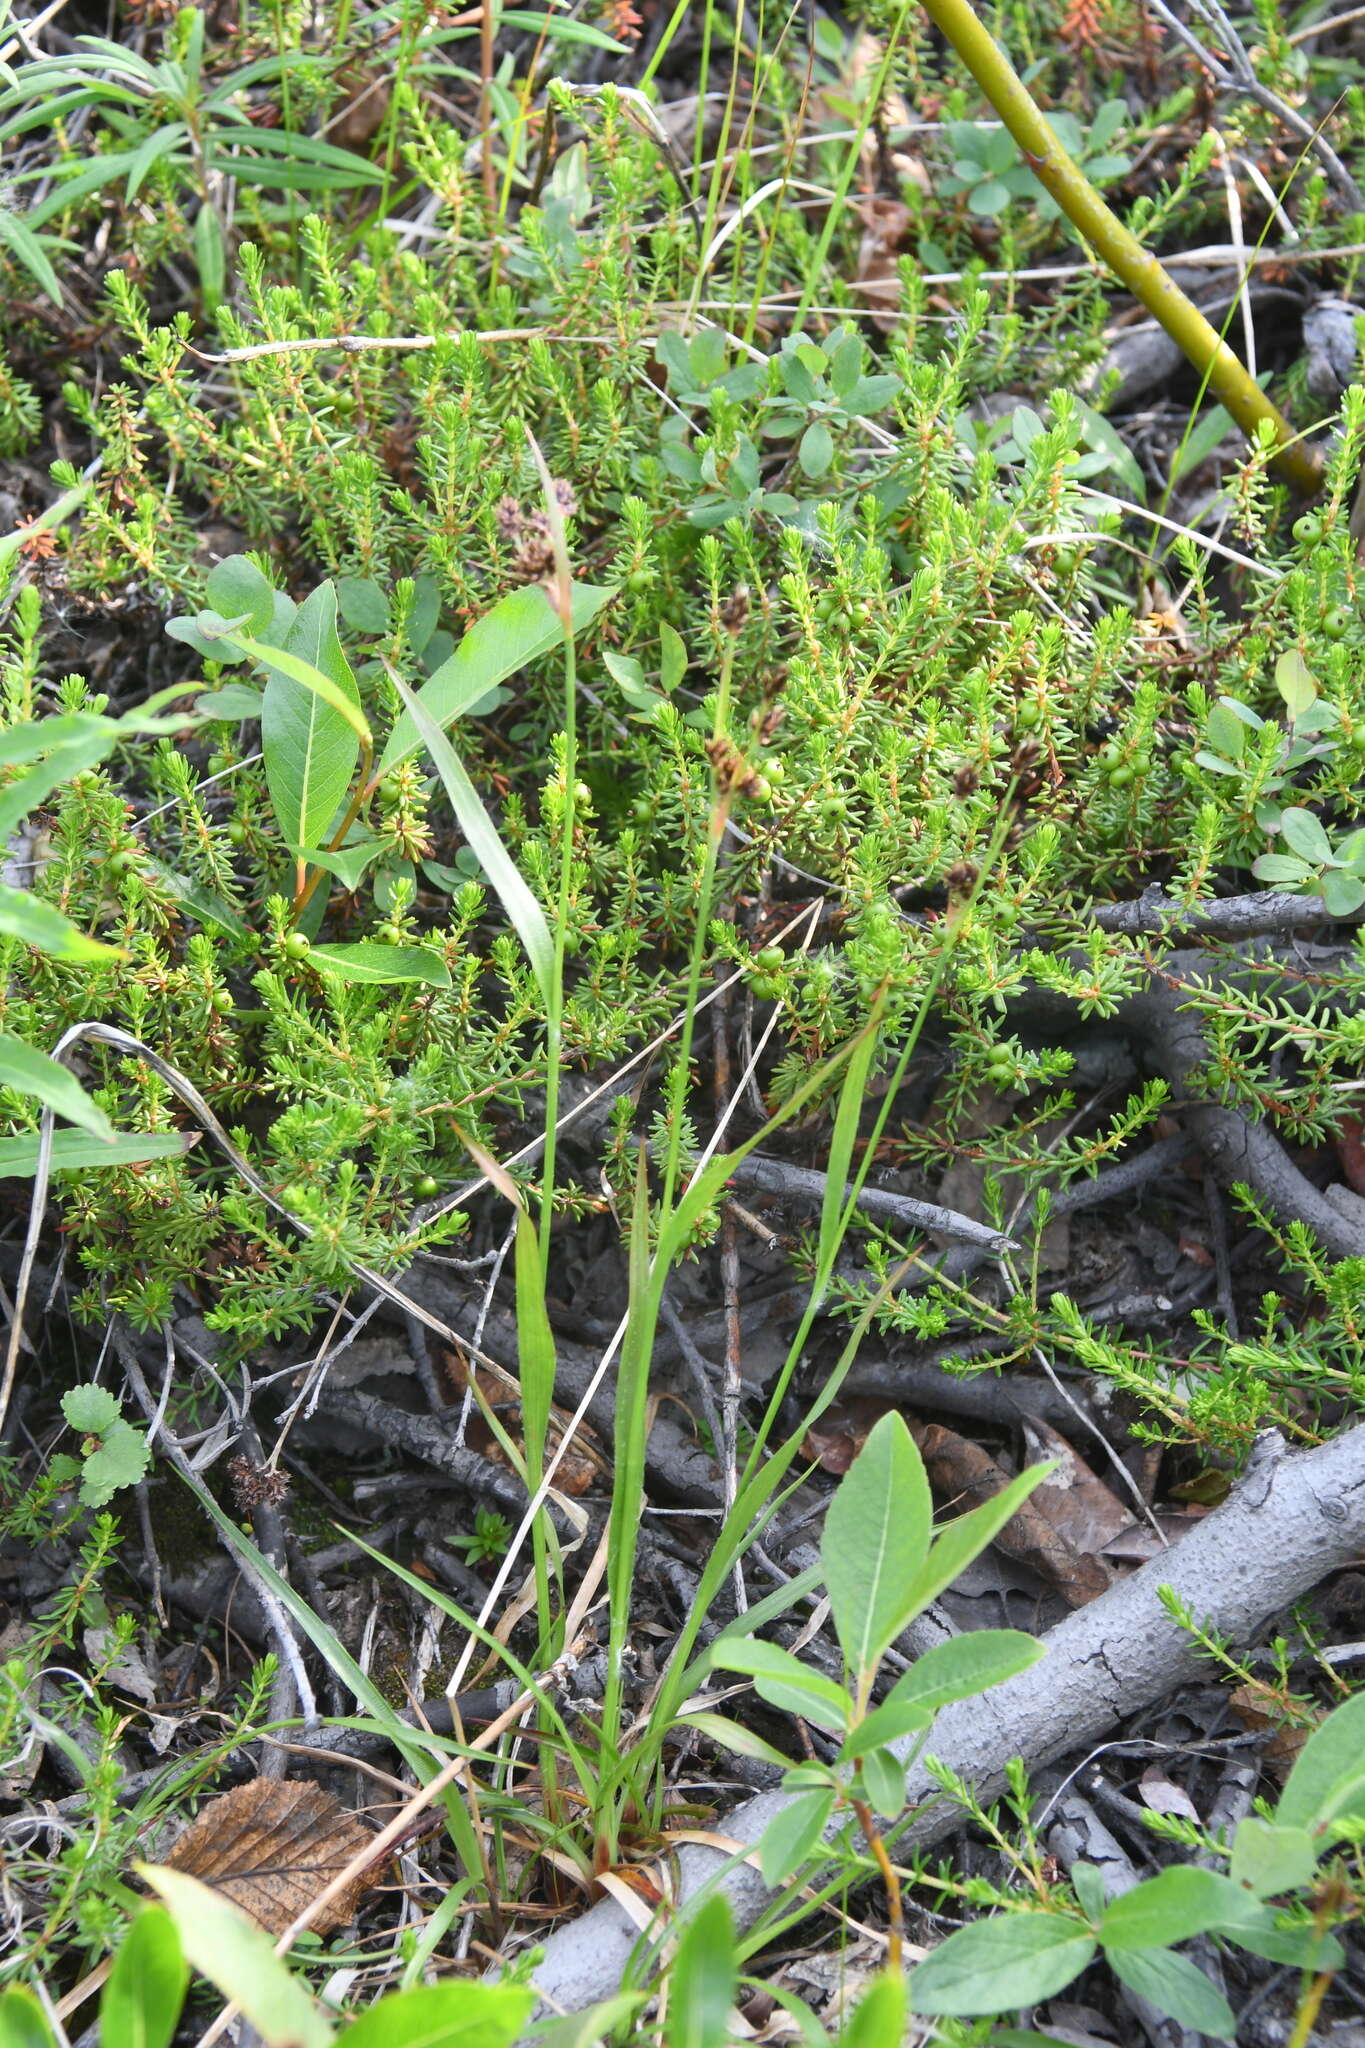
[133, 1864, 336, 2048]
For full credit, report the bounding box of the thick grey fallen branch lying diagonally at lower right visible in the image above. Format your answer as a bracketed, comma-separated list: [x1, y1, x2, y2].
[532, 1425, 1365, 2011]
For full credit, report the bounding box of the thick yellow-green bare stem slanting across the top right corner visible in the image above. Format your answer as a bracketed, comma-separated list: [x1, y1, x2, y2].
[916, 0, 1322, 498]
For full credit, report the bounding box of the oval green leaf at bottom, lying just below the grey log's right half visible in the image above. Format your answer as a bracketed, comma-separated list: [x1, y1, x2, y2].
[911, 1913, 1095, 2019]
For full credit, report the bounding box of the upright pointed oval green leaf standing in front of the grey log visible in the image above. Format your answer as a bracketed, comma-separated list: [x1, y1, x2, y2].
[821, 1409, 933, 1683]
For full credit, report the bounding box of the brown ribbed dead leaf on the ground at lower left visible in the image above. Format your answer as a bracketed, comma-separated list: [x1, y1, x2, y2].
[166, 1778, 383, 1933]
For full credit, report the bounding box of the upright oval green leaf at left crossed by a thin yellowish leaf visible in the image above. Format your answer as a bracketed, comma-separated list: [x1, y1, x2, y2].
[253, 584, 368, 846]
